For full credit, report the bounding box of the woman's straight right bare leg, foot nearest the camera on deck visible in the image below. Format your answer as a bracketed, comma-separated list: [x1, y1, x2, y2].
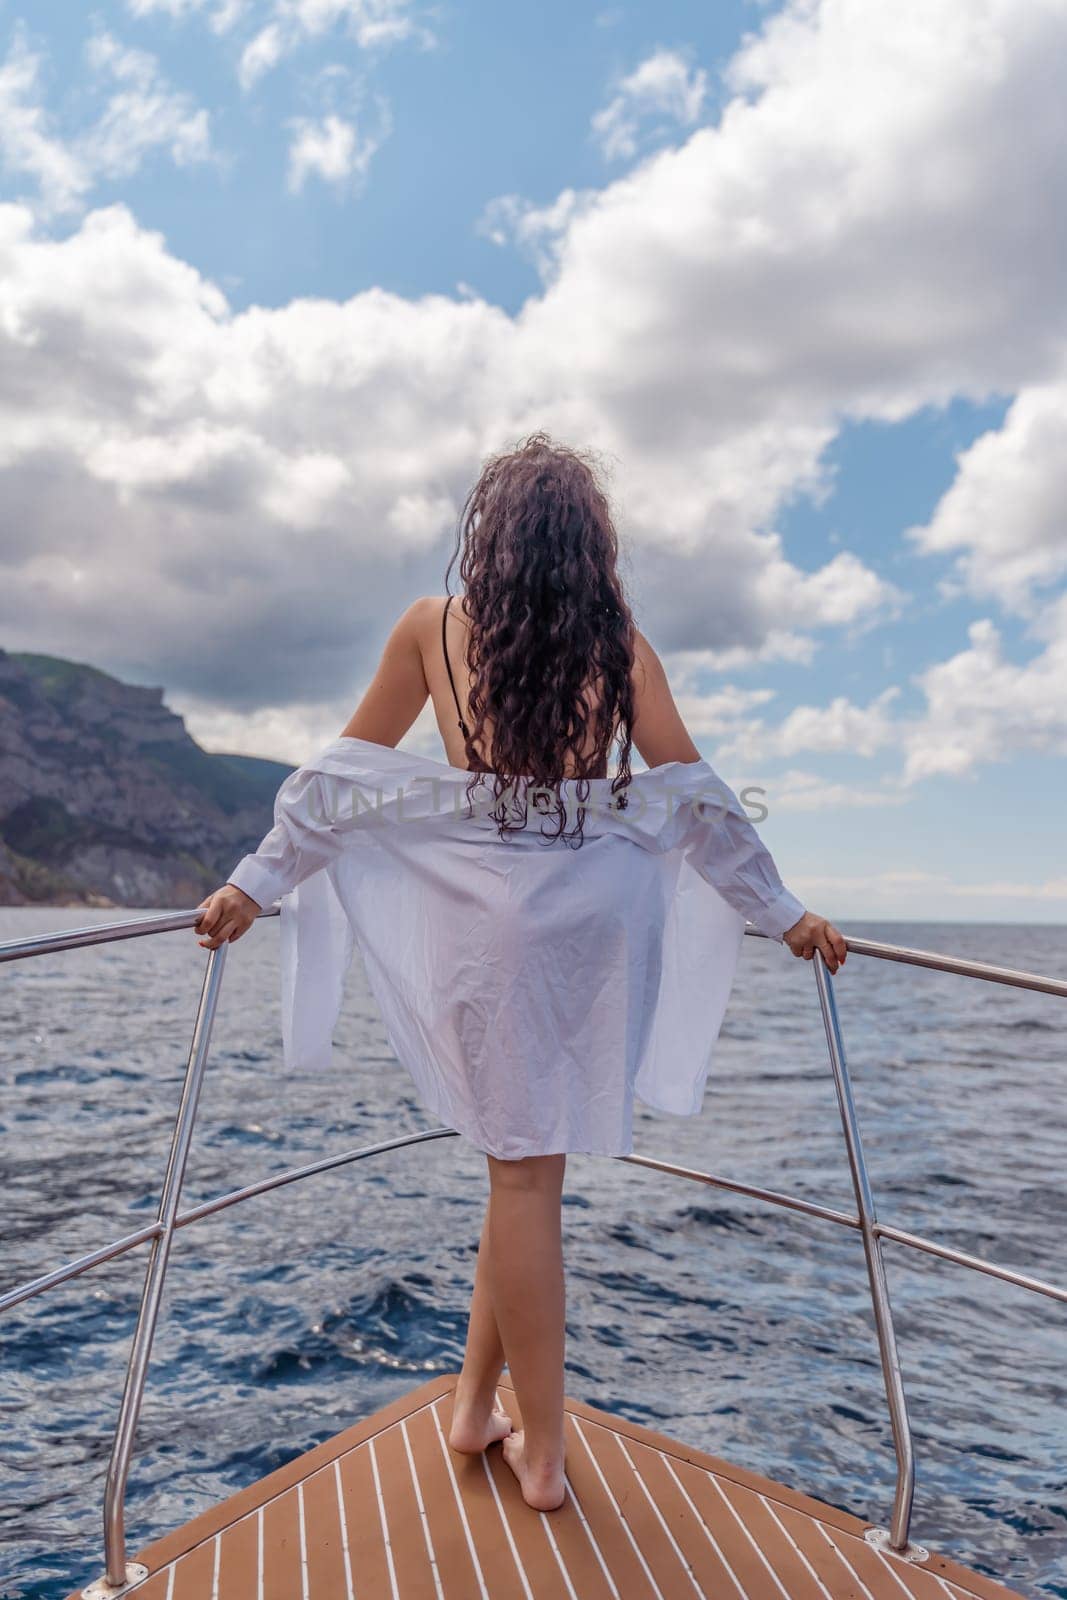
[488, 1155, 566, 1510]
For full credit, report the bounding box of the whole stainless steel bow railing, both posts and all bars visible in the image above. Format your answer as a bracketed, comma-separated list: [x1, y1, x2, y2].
[0, 907, 1067, 1600]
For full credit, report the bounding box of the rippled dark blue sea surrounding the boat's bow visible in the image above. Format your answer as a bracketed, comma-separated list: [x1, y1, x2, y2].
[0, 909, 1067, 1600]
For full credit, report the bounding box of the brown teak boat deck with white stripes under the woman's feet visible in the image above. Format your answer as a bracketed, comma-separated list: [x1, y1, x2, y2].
[70, 1376, 1021, 1600]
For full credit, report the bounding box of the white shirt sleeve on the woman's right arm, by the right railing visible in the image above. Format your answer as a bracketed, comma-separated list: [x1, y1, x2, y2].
[671, 762, 805, 941]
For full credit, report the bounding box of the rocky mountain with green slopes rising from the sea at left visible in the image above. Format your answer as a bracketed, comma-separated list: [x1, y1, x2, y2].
[0, 650, 293, 907]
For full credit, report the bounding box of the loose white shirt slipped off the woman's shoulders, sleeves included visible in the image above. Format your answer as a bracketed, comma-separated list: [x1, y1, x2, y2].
[229, 738, 805, 1158]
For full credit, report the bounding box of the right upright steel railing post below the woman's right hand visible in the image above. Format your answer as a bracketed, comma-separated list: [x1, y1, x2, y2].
[813, 950, 928, 1562]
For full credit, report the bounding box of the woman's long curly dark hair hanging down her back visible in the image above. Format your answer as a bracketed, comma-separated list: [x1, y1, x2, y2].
[445, 432, 635, 845]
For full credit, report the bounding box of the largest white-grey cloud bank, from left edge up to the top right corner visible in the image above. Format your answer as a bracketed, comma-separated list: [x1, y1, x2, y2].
[0, 0, 1067, 771]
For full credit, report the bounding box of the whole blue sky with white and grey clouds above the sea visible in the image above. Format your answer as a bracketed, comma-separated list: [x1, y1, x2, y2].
[0, 0, 1067, 923]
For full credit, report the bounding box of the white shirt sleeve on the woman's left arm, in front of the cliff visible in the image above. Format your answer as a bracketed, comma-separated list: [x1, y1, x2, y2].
[227, 766, 350, 910]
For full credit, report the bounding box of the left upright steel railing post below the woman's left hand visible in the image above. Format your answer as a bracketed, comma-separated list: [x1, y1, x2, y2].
[82, 944, 227, 1600]
